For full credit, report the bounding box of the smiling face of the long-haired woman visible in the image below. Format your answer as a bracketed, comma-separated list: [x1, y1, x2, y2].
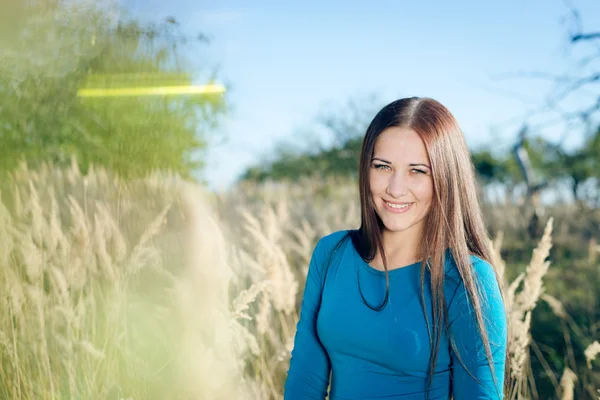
[369, 127, 433, 233]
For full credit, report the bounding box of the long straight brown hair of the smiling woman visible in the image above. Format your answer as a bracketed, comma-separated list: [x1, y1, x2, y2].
[350, 97, 510, 393]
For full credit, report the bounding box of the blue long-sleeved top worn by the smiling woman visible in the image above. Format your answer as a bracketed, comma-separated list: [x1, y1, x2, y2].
[284, 231, 507, 400]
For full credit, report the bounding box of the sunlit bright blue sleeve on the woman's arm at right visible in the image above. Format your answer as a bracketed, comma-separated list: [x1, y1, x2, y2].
[448, 260, 507, 400]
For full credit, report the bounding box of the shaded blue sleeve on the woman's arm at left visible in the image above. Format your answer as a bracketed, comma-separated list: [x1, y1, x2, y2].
[284, 240, 331, 400]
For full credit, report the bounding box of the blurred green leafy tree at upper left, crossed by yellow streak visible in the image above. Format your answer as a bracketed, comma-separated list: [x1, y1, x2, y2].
[0, 0, 226, 176]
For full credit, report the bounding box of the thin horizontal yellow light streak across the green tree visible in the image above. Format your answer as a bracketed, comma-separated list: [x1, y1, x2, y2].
[77, 84, 225, 97]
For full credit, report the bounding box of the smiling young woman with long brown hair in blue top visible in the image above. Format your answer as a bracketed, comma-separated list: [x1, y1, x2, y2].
[284, 97, 509, 400]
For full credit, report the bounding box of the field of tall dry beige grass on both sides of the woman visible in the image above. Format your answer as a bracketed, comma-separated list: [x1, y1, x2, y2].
[0, 166, 600, 400]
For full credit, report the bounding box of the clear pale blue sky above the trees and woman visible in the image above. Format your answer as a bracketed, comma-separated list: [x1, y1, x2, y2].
[120, 0, 600, 189]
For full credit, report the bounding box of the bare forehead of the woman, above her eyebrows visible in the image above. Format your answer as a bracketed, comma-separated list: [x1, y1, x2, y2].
[373, 126, 429, 162]
